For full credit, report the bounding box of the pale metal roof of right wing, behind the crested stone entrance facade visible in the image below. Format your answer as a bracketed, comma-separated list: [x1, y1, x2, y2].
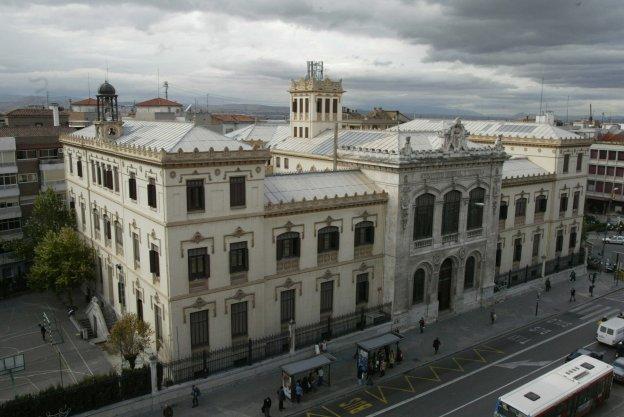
[388, 119, 583, 140]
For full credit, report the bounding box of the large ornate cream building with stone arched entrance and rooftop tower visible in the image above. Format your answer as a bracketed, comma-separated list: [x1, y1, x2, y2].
[61, 64, 588, 359]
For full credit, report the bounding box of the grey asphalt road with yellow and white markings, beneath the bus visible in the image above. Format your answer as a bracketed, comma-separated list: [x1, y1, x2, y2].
[302, 291, 624, 417]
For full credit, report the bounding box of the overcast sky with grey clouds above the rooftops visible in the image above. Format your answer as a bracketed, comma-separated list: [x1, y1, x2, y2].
[0, 0, 624, 117]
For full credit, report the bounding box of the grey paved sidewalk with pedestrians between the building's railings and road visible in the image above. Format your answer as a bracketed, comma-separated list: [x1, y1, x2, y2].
[136, 274, 624, 417]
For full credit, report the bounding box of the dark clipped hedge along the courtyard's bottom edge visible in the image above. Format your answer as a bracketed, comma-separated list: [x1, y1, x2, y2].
[0, 366, 152, 417]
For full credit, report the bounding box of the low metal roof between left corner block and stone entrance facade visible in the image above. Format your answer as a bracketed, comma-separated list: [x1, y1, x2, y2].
[264, 170, 380, 204]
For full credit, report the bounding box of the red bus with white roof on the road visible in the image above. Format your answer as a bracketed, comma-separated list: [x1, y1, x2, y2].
[494, 355, 613, 417]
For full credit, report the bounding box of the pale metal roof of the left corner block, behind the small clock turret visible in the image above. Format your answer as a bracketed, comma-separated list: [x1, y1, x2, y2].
[71, 120, 251, 152]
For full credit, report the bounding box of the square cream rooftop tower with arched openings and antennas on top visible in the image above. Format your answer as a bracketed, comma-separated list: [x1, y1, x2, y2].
[288, 61, 344, 139]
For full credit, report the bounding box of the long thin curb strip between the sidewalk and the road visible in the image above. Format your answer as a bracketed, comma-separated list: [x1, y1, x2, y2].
[283, 287, 624, 417]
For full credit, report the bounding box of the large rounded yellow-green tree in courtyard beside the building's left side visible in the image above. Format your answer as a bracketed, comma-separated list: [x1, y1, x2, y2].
[28, 227, 95, 305]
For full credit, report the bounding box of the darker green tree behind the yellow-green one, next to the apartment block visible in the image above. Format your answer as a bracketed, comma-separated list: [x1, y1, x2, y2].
[8, 188, 76, 260]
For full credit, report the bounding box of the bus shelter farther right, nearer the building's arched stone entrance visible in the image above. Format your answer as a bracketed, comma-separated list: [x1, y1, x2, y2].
[356, 333, 404, 379]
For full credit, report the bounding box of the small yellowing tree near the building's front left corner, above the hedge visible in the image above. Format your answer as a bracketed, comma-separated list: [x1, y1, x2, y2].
[108, 313, 152, 369]
